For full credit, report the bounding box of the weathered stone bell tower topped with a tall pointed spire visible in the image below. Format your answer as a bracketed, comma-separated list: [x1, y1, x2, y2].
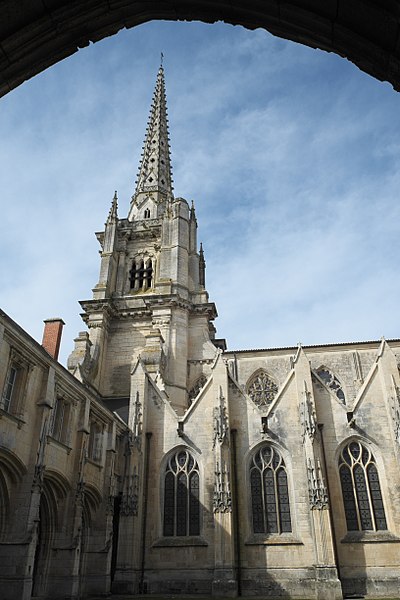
[68, 65, 220, 414]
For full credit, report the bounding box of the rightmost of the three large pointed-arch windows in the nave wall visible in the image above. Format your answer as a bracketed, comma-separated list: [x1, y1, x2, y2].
[339, 441, 387, 531]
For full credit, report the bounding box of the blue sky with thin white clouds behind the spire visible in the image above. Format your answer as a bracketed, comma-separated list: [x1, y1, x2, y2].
[0, 22, 400, 362]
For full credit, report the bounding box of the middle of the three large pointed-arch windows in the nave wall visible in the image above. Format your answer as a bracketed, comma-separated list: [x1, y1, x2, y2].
[250, 445, 292, 534]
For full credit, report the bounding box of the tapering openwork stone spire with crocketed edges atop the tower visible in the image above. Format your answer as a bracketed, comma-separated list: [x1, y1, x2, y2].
[131, 64, 173, 216]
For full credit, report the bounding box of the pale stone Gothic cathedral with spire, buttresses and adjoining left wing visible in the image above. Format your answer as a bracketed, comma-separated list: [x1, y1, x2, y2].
[0, 66, 400, 600]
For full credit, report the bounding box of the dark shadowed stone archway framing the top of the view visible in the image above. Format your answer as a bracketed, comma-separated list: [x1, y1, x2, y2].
[0, 0, 400, 96]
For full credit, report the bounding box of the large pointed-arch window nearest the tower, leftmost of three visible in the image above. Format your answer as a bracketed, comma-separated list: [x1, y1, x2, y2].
[164, 449, 200, 536]
